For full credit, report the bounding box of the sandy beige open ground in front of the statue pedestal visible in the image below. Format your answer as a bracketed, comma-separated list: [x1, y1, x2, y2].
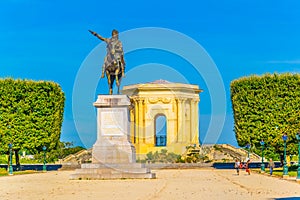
[0, 168, 300, 200]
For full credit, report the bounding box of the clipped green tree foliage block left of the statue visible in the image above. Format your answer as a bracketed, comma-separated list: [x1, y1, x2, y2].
[0, 79, 65, 153]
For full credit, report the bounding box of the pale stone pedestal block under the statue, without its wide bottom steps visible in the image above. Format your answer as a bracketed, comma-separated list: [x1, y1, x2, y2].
[92, 95, 135, 164]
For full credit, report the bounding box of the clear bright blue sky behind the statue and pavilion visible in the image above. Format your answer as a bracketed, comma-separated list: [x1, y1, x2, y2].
[0, 0, 300, 147]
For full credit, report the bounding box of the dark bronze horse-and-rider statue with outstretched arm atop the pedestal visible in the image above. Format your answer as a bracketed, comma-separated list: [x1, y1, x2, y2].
[89, 30, 125, 94]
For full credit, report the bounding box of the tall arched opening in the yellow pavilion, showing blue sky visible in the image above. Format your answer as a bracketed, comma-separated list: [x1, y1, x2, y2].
[154, 114, 167, 147]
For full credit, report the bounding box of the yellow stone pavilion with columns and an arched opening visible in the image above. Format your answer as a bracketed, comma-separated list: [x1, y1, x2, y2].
[122, 80, 202, 159]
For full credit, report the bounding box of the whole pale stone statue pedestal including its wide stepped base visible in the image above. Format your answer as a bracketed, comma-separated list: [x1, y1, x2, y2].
[70, 95, 155, 179]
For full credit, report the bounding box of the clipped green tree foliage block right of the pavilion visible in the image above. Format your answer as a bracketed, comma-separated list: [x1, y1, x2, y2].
[230, 74, 300, 157]
